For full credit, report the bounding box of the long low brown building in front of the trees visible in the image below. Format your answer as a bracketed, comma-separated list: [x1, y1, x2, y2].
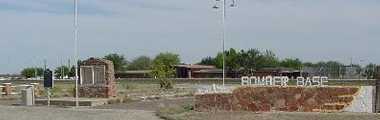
[115, 64, 302, 79]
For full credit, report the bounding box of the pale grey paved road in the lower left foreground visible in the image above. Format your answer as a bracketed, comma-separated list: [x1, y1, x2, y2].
[0, 106, 160, 120]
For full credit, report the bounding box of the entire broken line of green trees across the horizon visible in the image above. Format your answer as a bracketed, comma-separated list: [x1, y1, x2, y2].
[21, 48, 377, 78]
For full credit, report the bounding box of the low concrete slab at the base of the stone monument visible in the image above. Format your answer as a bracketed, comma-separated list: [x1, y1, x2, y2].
[35, 98, 117, 106]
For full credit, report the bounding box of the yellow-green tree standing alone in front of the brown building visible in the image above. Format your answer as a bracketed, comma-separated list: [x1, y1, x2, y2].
[151, 53, 180, 89]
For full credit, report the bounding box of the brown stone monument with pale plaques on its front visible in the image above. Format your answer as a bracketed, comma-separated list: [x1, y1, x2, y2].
[79, 58, 116, 98]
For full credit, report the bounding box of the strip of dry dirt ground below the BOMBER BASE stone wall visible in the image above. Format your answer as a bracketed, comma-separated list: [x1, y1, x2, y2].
[170, 112, 380, 120]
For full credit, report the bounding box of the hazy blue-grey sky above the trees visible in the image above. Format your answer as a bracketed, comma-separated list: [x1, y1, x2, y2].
[0, 0, 380, 73]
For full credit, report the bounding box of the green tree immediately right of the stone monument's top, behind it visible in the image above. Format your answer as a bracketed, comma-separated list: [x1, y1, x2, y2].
[104, 53, 128, 72]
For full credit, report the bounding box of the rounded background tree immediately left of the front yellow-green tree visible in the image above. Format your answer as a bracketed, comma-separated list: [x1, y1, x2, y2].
[127, 56, 152, 70]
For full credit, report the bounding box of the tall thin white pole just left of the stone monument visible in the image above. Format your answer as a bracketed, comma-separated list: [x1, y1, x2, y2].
[74, 0, 79, 107]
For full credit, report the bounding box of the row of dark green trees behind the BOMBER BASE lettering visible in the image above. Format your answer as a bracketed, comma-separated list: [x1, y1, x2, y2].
[198, 48, 377, 79]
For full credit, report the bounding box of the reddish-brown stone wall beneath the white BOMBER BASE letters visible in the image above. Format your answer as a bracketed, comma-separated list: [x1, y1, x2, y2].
[195, 86, 359, 112]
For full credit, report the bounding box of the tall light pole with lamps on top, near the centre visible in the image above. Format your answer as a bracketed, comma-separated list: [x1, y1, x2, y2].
[213, 0, 237, 86]
